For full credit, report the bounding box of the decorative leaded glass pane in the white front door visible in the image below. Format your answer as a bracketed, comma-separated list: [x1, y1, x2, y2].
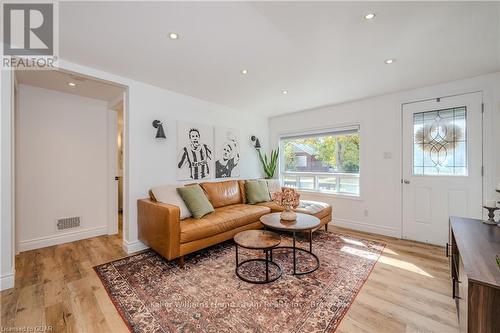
[413, 107, 467, 176]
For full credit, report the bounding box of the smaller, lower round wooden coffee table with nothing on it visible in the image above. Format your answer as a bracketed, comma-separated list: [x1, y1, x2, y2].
[234, 230, 283, 284]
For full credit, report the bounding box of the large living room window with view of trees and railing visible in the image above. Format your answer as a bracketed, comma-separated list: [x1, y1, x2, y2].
[280, 126, 359, 196]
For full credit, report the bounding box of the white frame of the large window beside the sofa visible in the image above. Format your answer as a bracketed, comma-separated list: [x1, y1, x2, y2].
[278, 122, 363, 200]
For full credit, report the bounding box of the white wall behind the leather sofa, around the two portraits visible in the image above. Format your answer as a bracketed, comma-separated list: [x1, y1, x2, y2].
[126, 80, 268, 249]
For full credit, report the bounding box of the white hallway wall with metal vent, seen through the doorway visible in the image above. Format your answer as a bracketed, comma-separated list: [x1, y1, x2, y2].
[16, 85, 108, 251]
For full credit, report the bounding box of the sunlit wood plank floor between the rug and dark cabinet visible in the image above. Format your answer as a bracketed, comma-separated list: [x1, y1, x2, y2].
[334, 227, 458, 333]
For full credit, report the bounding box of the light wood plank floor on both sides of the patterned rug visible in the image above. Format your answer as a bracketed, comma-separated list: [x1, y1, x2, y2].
[1, 227, 458, 333]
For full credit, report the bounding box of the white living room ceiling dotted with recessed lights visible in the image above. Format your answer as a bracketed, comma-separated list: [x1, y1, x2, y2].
[59, 2, 500, 116]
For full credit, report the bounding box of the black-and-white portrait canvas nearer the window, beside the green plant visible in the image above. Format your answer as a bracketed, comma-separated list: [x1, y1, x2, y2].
[215, 127, 240, 178]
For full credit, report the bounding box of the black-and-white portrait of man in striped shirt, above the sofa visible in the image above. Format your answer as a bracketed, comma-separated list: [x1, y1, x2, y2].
[177, 121, 214, 180]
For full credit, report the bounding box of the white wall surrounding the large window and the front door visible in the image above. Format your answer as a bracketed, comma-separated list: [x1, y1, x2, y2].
[269, 73, 500, 237]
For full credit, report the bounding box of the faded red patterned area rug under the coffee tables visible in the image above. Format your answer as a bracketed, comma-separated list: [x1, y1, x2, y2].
[94, 231, 384, 332]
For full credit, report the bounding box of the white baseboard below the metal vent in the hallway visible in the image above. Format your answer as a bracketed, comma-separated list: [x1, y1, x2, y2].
[19, 225, 108, 252]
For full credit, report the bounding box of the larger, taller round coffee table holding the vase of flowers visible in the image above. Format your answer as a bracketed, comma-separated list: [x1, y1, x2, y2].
[260, 213, 320, 275]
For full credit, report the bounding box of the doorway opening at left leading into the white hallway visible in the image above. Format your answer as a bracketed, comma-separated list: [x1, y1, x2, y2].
[14, 70, 126, 253]
